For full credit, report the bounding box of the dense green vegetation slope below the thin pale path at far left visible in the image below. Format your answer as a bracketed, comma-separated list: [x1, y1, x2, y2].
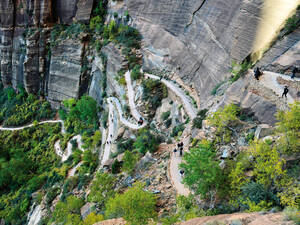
[0, 124, 64, 224]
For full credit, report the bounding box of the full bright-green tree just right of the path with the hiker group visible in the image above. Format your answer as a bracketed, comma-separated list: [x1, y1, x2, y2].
[180, 140, 226, 202]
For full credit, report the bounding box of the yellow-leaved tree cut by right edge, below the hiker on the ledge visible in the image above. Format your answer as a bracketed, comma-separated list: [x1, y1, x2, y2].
[277, 102, 300, 153]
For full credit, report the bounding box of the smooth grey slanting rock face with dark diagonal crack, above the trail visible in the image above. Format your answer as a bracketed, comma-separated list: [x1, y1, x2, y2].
[126, 0, 262, 100]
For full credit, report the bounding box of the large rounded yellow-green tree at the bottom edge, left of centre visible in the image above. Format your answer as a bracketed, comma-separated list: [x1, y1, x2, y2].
[105, 183, 157, 225]
